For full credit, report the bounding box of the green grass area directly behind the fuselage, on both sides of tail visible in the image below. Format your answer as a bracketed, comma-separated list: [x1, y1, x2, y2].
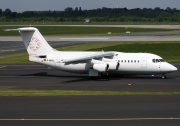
[0, 42, 180, 64]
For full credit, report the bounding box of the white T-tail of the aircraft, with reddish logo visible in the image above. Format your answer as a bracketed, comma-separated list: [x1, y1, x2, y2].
[5, 27, 54, 57]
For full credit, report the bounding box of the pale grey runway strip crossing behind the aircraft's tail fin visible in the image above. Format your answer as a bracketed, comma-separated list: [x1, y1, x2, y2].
[0, 34, 180, 42]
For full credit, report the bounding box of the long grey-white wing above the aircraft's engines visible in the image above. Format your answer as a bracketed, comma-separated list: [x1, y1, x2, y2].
[63, 52, 114, 63]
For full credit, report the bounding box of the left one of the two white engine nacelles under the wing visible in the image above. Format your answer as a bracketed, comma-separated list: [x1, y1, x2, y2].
[93, 63, 109, 72]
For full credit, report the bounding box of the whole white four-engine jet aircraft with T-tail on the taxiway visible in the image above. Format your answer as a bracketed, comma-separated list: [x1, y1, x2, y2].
[5, 27, 177, 79]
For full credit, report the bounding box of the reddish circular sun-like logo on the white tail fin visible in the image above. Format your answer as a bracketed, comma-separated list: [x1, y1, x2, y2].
[28, 37, 42, 52]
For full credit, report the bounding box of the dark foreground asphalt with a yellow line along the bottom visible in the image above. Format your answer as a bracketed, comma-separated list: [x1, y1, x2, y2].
[0, 96, 180, 126]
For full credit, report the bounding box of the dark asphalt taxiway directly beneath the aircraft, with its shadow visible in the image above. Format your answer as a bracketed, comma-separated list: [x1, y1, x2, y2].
[0, 63, 180, 91]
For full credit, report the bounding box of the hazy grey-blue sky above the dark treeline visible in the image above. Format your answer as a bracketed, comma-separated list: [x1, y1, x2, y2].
[0, 0, 180, 12]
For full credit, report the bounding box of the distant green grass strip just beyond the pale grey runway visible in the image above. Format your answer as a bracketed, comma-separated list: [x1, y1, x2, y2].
[0, 26, 172, 36]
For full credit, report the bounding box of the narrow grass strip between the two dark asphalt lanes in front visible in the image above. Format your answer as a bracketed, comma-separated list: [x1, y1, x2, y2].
[0, 89, 180, 97]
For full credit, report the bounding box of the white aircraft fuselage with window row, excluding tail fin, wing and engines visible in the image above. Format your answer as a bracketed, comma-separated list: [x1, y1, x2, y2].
[30, 51, 177, 75]
